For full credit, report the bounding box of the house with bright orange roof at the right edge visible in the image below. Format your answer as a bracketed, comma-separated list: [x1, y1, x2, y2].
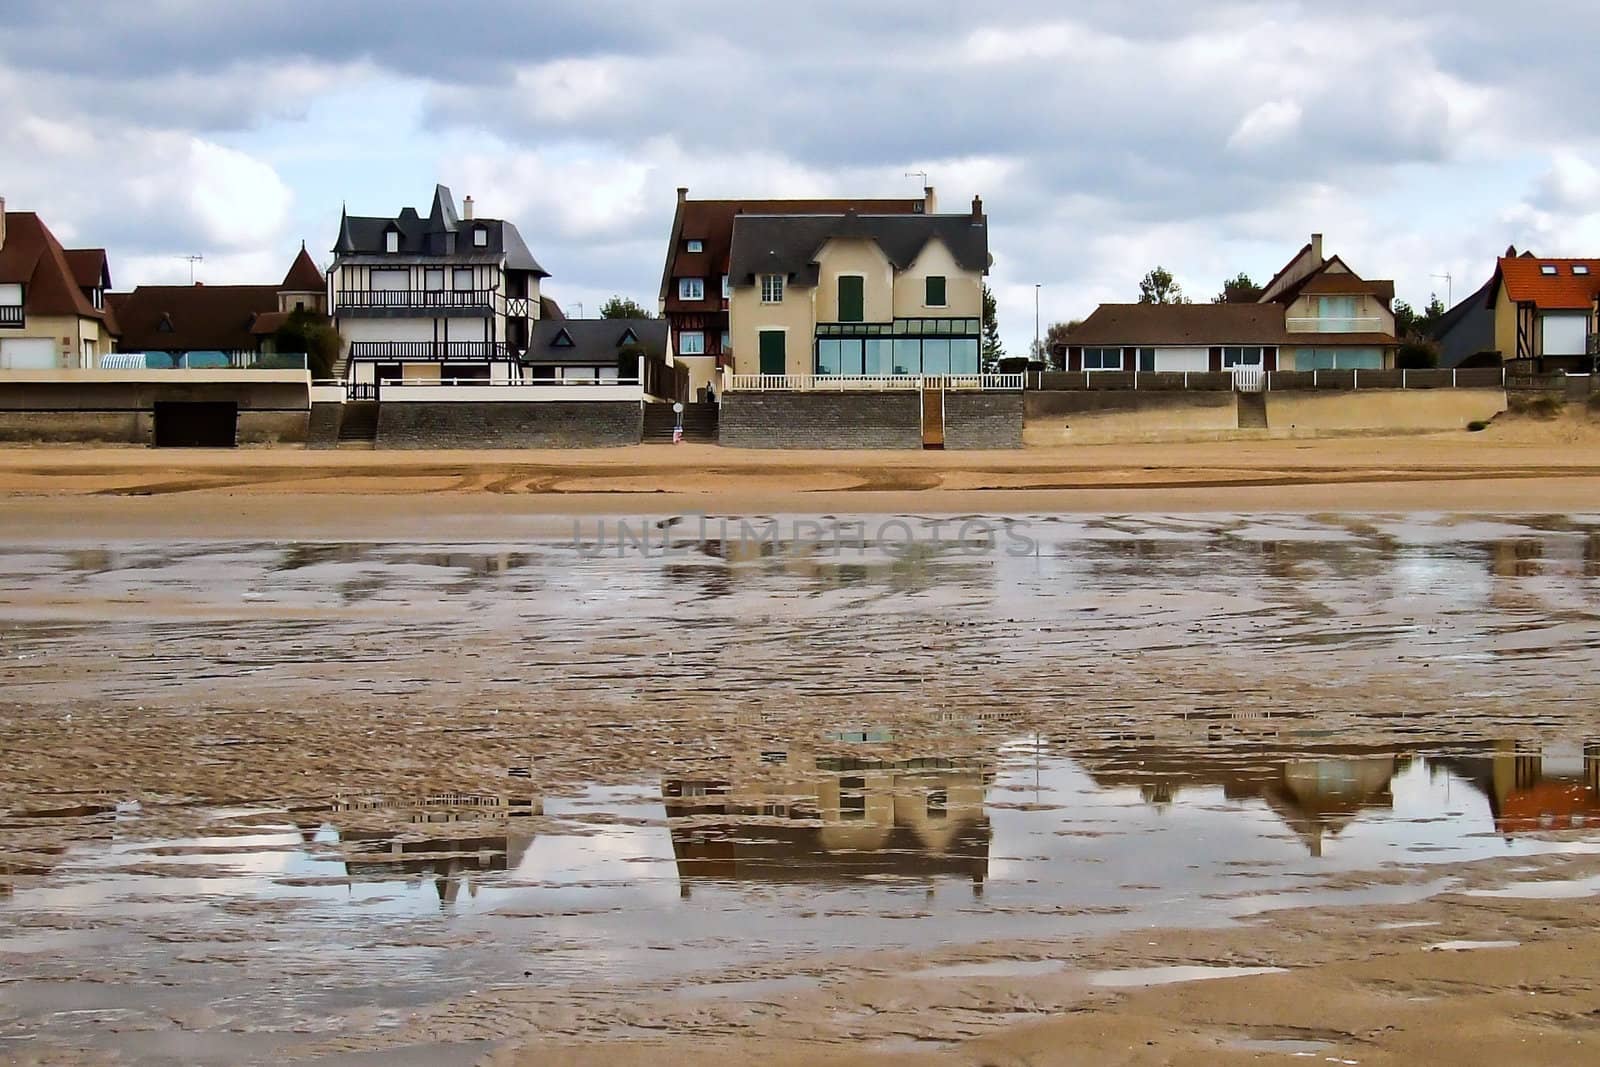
[1485, 253, 1600, 371]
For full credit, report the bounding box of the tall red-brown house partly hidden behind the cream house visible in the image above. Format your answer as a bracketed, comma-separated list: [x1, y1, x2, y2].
[661, 187, 938, 395]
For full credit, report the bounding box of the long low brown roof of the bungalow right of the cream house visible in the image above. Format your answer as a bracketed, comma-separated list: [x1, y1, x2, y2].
[1066, 304, 1395, 347]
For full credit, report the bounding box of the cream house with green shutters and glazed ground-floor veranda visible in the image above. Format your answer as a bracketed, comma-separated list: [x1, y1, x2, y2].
[728, 198, 989, 378]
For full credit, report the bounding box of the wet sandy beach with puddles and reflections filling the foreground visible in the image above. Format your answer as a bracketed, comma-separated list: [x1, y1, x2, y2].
[0, 445, 1600, 1065]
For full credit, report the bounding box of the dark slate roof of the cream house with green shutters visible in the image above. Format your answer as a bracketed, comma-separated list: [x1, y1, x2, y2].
[728, 211, 989, 285]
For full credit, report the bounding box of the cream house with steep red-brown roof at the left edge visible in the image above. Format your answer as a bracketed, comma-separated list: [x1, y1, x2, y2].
[0, 198, 117, 370]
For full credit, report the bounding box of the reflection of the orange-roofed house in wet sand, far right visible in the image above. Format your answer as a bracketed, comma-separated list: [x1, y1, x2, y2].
[1445, 741, 1600, 833]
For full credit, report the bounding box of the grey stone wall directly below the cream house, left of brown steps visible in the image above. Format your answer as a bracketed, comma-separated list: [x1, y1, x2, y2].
[717, 392, 922, 448]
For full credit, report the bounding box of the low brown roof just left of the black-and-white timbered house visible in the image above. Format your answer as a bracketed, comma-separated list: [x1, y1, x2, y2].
[112, 285, 278, 352]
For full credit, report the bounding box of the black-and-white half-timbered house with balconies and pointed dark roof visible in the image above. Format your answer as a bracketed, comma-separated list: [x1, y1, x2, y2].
[330, 186, 549, 397]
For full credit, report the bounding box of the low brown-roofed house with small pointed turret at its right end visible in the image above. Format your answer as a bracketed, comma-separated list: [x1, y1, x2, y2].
[109, 243, 328, 366]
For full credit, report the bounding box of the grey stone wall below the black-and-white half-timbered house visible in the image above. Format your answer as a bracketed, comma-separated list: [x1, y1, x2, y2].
[378, 400, 645, 448]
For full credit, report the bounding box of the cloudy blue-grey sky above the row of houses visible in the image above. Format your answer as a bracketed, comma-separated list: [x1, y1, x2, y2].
[0, 0, 1600, 350]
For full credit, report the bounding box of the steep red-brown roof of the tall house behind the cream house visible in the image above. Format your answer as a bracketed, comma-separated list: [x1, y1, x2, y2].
[661, 197, 926, 310]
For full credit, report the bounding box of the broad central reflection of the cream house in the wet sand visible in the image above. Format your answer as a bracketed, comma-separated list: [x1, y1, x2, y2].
[662, 757, 992, 886]
